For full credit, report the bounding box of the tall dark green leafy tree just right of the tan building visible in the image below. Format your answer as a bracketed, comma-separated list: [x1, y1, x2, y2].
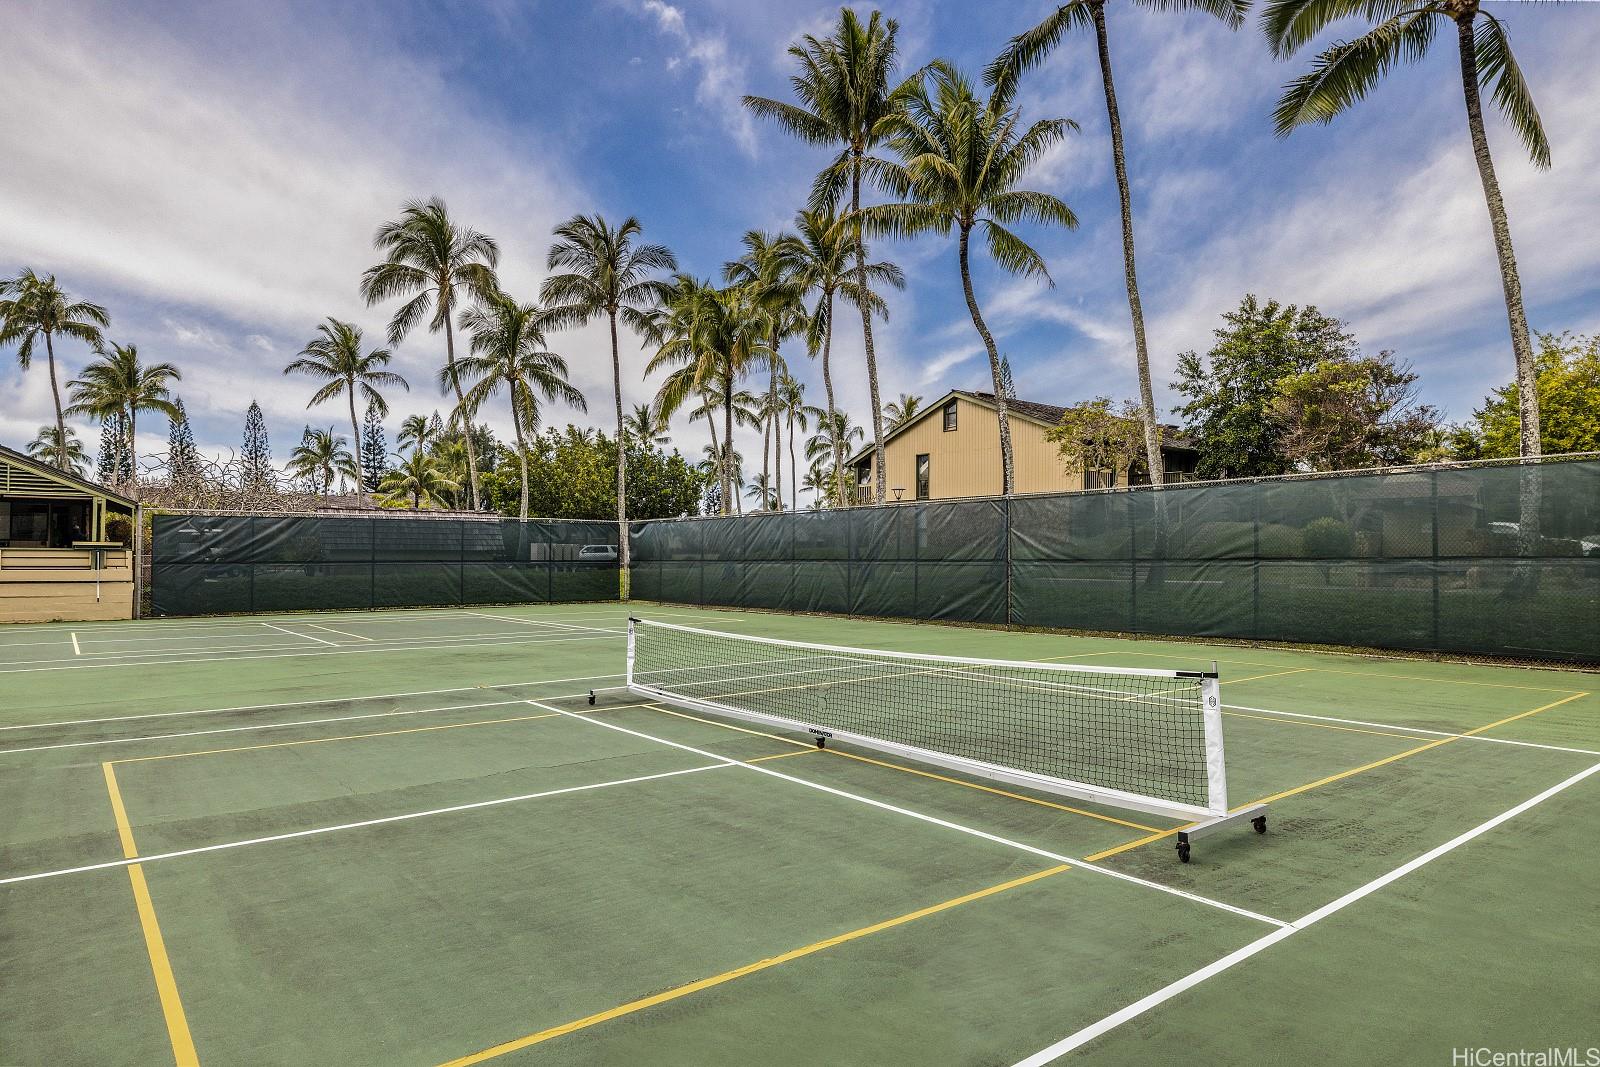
[1173, 294, 1357, 478]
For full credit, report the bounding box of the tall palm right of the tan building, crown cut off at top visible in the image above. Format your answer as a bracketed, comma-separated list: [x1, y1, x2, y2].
[984, 0, 1250, 485]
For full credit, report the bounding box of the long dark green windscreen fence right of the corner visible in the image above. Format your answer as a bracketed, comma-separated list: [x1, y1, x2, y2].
[632, 459, 1600, 662]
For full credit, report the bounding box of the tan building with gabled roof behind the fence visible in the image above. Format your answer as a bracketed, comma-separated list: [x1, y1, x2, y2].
[850, 389, 1198, 502]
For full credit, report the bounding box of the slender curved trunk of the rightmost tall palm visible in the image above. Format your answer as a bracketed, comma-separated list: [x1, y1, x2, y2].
[1456, 11, 1542, 563]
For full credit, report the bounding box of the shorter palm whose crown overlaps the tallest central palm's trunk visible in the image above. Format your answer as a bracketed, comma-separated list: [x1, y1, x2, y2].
[782, 210, 906, 499]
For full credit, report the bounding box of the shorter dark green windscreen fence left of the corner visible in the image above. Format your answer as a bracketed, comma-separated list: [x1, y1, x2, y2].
[150, 514, 618, 616]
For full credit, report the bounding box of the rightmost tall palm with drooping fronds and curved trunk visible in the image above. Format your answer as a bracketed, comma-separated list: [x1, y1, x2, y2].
[1261, 0, 1550, 456]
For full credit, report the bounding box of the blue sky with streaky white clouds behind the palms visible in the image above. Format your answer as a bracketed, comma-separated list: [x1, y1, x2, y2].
[0, 0, 1600, 502]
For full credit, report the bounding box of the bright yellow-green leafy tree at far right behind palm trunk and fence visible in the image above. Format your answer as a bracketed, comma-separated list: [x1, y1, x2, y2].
[1453, 333, 1600, 459]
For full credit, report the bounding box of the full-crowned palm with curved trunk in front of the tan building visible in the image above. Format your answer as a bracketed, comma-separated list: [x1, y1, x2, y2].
[861, 61, 1078, 496]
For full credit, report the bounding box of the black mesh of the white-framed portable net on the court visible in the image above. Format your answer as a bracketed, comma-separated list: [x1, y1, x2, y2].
[629, 621, 1210, 808]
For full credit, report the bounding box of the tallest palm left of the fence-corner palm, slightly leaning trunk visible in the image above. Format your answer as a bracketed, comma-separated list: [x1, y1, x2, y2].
[362, 197, 499, 510]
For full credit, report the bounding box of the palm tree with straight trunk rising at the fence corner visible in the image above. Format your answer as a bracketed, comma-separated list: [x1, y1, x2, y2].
[539, 214, 678, 581]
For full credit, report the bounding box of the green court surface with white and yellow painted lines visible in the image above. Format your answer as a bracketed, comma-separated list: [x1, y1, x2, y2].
[0, 603, 1600, 1067]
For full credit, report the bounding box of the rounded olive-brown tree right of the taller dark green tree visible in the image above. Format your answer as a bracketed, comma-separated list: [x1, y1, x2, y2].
[1269, 352, 1438, 470]
